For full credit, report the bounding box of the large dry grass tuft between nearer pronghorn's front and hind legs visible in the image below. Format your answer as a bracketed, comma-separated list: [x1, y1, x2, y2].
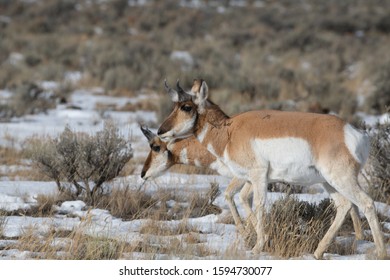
[241, 195, 360, 259]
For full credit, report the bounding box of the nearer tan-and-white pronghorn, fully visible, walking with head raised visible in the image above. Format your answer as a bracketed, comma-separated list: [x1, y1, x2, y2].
[158, 80, 386, 259]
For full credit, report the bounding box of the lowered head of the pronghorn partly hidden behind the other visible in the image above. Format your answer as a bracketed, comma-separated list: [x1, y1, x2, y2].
[140, 125, 174, 180]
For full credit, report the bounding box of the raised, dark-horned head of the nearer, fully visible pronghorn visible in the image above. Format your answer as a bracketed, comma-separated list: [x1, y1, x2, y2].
[158, 79, 208, 141]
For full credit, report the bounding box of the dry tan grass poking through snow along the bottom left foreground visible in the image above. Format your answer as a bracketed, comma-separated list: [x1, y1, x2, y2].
[0, 213, 213, 260]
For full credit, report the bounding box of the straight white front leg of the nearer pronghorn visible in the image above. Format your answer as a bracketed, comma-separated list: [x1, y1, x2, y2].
[249, 167, 268, 253]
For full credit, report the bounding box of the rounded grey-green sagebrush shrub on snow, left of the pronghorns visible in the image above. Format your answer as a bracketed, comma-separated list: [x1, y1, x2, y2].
[27, 122, 133, 204]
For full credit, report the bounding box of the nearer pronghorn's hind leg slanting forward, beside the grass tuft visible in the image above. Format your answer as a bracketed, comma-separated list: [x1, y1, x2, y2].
[314, 184, 352, 259]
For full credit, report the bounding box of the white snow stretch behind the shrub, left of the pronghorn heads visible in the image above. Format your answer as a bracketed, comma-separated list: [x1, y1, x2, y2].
[0, 89, 156, 149]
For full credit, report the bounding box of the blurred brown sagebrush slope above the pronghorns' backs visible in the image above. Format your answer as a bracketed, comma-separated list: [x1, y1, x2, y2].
[0, 0, 390, 122]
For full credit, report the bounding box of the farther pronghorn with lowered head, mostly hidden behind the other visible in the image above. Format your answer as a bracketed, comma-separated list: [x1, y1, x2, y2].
[141, 126, 256, 233]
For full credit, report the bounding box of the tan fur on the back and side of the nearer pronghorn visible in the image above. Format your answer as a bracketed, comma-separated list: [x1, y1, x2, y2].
[195, 111, 359, 170]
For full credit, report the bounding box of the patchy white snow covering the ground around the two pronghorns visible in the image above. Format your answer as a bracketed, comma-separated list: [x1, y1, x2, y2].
[0, 86, 390, 260]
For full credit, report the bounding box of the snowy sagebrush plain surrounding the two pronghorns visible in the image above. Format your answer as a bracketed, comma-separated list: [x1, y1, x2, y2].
[0, 0, 390, 259]
